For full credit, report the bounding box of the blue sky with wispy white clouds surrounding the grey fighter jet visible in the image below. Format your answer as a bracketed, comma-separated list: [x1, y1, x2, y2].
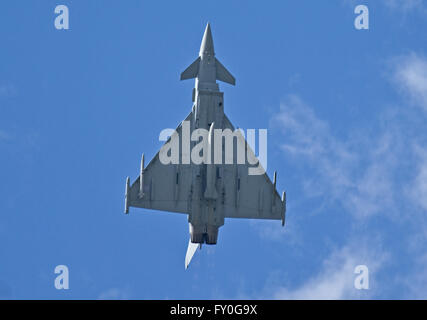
[0, 0, 427, 299]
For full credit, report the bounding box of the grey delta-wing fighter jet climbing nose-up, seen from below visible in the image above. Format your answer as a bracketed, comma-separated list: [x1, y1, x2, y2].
[125, 23, 286, 268]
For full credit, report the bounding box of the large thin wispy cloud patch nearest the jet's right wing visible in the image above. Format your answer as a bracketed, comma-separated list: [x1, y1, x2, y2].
[273, 96, 399, 217]
